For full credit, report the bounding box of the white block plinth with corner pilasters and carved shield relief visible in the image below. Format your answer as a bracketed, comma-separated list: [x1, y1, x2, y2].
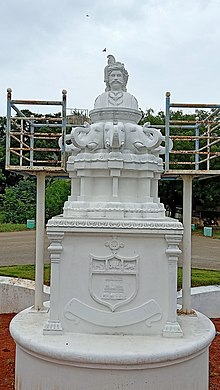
[44, 217, 182, 337]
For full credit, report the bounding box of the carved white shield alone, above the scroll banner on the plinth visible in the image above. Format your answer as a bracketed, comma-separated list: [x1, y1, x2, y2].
[89, 254, 139, 311]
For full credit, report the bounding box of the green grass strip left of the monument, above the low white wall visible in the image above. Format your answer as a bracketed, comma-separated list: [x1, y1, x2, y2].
[0, 264, 50, 285]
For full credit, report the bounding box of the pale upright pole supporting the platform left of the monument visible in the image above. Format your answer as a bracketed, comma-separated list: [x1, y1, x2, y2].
[34, 172, 45, 310]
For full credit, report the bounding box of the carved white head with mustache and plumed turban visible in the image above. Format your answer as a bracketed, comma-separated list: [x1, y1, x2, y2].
[104, 55, 128, 92]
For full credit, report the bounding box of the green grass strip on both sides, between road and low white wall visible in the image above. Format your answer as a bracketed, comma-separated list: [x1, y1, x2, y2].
[0, 264, 220, 289]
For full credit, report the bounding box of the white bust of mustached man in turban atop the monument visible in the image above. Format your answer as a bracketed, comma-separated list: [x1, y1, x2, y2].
[94, 55, 138, 110]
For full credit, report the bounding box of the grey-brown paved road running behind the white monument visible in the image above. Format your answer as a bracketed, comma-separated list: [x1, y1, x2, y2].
[0, 230, 220, 270]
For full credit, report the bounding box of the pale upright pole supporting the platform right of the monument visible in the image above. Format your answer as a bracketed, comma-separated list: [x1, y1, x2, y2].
[182, 175, 193, 314]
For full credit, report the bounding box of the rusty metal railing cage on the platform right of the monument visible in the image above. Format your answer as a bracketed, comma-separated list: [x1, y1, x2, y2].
[163, 92, 220, 174]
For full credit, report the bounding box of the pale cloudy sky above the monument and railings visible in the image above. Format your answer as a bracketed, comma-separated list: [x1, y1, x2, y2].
[0, 0, 220, 115]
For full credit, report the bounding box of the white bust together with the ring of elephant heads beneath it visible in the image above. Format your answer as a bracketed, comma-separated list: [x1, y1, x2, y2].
[60, 55, 172, 156]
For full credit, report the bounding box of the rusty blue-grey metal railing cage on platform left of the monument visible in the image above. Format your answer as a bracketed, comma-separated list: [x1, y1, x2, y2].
[6, 88, 67, 172]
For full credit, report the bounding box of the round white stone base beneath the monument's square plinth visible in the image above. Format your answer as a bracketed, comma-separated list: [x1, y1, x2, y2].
[10, 309, 215, 390]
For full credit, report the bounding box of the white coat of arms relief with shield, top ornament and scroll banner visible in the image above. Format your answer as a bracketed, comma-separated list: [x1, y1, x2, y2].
[64, 237, 162, 327]
